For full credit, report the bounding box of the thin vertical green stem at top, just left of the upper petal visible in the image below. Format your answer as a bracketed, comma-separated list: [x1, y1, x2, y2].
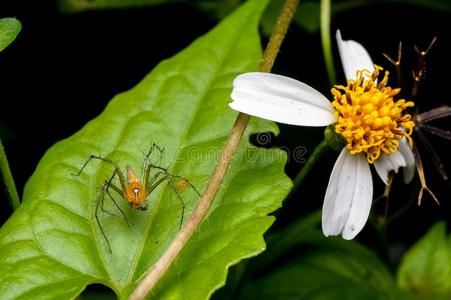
[320, 0, 337, 86]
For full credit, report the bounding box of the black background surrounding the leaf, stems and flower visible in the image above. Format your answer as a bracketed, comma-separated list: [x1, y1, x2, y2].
[0, 0, 451, 272]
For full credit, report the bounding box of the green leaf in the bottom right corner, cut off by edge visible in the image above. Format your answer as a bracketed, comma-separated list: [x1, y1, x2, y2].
[397, 222, 451, 299]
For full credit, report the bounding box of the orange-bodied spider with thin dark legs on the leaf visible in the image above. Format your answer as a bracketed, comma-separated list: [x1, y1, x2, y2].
[73, 143, 200, 252]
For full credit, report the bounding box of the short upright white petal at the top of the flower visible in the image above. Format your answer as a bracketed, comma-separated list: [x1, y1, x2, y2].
[336, 30, 374, 80]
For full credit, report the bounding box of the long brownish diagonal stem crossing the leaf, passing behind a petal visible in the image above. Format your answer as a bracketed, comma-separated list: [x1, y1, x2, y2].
[129, 0, 299, 299]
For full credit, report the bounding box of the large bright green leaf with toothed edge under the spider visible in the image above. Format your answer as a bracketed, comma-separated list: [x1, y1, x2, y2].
[0, 0, 291, 299]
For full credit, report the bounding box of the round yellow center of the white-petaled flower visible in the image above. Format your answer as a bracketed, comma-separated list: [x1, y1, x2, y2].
[332, 66, 415, 163]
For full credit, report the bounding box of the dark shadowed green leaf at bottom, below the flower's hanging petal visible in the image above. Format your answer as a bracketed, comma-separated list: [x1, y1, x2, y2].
[240, 218, 410, 299]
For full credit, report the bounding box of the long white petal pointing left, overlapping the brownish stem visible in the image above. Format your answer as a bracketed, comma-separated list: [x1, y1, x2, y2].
[233, 72, 335, 126]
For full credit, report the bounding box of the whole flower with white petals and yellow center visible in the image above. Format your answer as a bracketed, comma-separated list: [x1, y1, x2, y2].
[230, 31, 415, 239]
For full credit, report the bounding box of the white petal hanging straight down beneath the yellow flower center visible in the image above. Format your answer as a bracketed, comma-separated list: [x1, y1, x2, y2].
[322, 148, 373, 239]
